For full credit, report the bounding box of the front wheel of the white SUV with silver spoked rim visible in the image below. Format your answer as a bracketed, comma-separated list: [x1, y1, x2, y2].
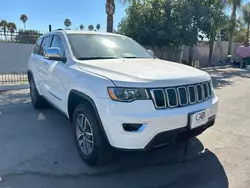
[73, 104, 112, 166]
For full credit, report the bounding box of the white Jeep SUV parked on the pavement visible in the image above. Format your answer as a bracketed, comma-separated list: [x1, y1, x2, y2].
[28, 30, 218, 165]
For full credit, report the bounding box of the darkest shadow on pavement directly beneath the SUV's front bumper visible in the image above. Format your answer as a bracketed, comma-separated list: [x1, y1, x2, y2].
[93, 138, 228, 188]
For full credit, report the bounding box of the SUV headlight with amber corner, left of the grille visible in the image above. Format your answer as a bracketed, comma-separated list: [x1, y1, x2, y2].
[108, 87, 149, 102]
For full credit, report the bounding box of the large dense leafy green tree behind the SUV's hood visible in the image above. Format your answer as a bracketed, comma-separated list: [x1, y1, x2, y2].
[118, 0, 226, 65]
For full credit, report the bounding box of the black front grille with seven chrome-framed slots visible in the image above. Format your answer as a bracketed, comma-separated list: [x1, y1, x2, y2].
[150, 82, 212, 109]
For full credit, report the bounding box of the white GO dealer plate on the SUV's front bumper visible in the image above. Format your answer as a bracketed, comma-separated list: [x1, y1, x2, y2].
[189, 110, 208, 129]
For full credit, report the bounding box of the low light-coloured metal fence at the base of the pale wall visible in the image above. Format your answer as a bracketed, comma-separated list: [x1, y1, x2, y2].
[0, 71, 28, 86]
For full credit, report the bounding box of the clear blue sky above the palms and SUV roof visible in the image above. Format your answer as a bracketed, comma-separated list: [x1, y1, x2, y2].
[0, 0, 126, 31]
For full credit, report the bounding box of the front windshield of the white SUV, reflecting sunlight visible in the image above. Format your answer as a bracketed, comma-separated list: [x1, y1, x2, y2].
[68, 34, 154, 60]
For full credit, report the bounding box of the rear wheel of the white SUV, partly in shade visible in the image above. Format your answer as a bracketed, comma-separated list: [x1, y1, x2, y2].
[29, 78, 47, 109]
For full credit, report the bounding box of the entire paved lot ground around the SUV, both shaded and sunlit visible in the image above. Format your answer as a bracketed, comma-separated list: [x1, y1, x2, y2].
[0, 68, 250, 188]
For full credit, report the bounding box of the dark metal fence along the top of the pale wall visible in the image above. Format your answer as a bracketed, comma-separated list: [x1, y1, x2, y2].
[0, 29, 47, 44]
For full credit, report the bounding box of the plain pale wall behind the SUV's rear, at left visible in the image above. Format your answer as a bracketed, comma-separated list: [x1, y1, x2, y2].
[0, 42, 34, 72]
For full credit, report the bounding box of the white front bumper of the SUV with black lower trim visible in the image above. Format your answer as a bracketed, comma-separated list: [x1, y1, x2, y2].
[96, 96, 219, 150]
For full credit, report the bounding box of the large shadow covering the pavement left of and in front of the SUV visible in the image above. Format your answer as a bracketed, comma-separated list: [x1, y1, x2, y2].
[0, 92, 228, 188]
